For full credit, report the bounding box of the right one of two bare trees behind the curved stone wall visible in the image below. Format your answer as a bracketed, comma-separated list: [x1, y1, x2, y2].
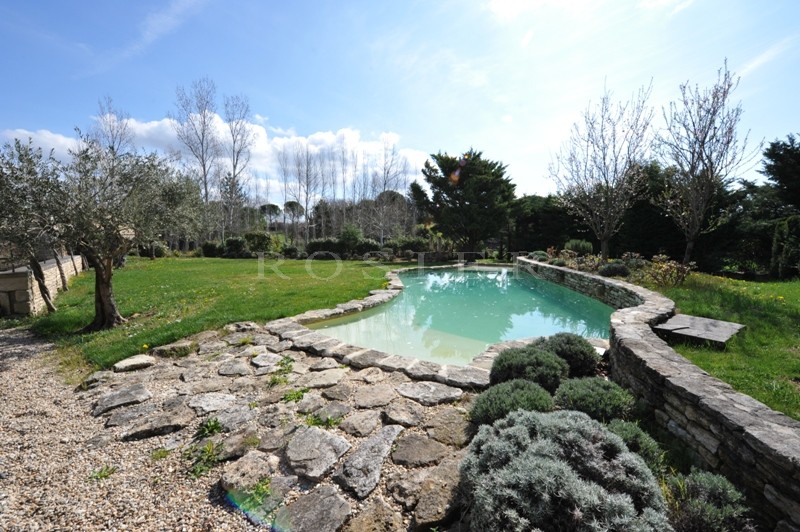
[656, 61, 762, 263]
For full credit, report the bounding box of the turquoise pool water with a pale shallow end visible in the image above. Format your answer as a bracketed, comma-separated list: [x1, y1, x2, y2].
[308, 268, 613, 365]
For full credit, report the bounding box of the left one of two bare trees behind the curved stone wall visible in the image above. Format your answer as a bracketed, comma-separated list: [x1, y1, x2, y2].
[550, 81, 653, 260]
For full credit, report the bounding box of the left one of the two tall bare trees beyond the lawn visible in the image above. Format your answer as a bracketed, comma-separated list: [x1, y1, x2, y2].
[169, 78, 222, 238]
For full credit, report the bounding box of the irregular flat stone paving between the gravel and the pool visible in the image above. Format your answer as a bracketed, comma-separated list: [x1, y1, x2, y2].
[77, 321, 488, 532]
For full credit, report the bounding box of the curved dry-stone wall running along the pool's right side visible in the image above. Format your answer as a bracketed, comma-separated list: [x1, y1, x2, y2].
[518, 258, 800, 531]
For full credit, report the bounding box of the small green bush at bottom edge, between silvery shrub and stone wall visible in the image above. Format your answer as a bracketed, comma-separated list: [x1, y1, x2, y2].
[663, 470, 756, 532]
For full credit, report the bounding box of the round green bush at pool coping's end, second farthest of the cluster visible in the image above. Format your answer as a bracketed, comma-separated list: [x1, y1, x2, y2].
[489, 346, 569, 393]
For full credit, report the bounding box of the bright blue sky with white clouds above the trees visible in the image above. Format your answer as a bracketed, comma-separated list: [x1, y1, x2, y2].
[0, 0, 800, 194]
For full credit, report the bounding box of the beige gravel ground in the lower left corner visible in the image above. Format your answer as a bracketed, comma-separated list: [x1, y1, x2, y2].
[0, 329, 263, 531]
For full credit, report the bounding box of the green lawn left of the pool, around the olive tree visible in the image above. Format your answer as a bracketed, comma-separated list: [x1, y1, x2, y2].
[32, 258, 389, 370]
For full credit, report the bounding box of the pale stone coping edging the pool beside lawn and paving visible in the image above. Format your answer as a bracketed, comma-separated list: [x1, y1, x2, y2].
[265, 263, 608, 390]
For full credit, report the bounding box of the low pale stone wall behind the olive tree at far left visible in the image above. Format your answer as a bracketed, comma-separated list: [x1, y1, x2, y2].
[0, 256, 81, 316]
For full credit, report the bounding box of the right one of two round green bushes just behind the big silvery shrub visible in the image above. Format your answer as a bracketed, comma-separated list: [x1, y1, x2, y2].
[554, 377, 635, 421]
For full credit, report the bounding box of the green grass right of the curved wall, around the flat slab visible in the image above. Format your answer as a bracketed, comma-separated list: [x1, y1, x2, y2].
[659, 274, 800, 420]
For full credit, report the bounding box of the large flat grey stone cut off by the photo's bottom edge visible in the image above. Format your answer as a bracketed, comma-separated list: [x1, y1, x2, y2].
[275, 485, 352, 532]
